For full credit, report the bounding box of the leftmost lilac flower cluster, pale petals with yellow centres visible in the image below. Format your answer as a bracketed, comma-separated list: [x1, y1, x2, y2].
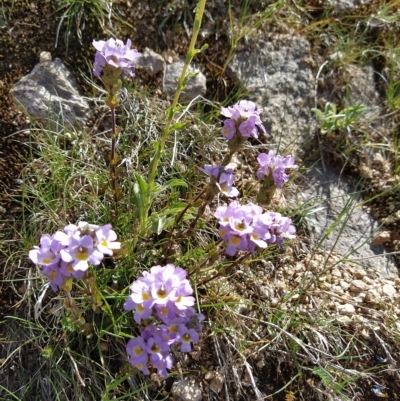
[29, 221, 121, 291]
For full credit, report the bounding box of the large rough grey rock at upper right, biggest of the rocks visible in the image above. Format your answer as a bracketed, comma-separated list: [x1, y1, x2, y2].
[229, 35, 316, 153]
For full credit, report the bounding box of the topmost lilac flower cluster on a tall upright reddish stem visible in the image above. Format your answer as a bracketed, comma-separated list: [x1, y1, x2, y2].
[92, 38, 140, 77]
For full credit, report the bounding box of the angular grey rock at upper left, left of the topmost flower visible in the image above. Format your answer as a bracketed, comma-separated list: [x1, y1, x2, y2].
[11, 58, 90, 132]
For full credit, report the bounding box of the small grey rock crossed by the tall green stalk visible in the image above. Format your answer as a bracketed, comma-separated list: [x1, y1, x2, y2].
[163, 60, 207, 103]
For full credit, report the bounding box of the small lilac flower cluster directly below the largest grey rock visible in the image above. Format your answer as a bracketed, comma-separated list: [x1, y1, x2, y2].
[257, 150, 298, 188]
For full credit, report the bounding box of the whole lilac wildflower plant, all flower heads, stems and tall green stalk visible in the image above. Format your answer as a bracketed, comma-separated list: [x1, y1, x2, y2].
[29, 0, 297, 384]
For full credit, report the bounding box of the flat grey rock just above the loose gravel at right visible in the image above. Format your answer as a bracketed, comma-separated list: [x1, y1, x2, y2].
[303, 164, 399, 278]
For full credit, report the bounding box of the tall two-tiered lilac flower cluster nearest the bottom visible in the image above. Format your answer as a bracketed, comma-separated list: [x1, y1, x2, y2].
[124, 264, 204, 377]
